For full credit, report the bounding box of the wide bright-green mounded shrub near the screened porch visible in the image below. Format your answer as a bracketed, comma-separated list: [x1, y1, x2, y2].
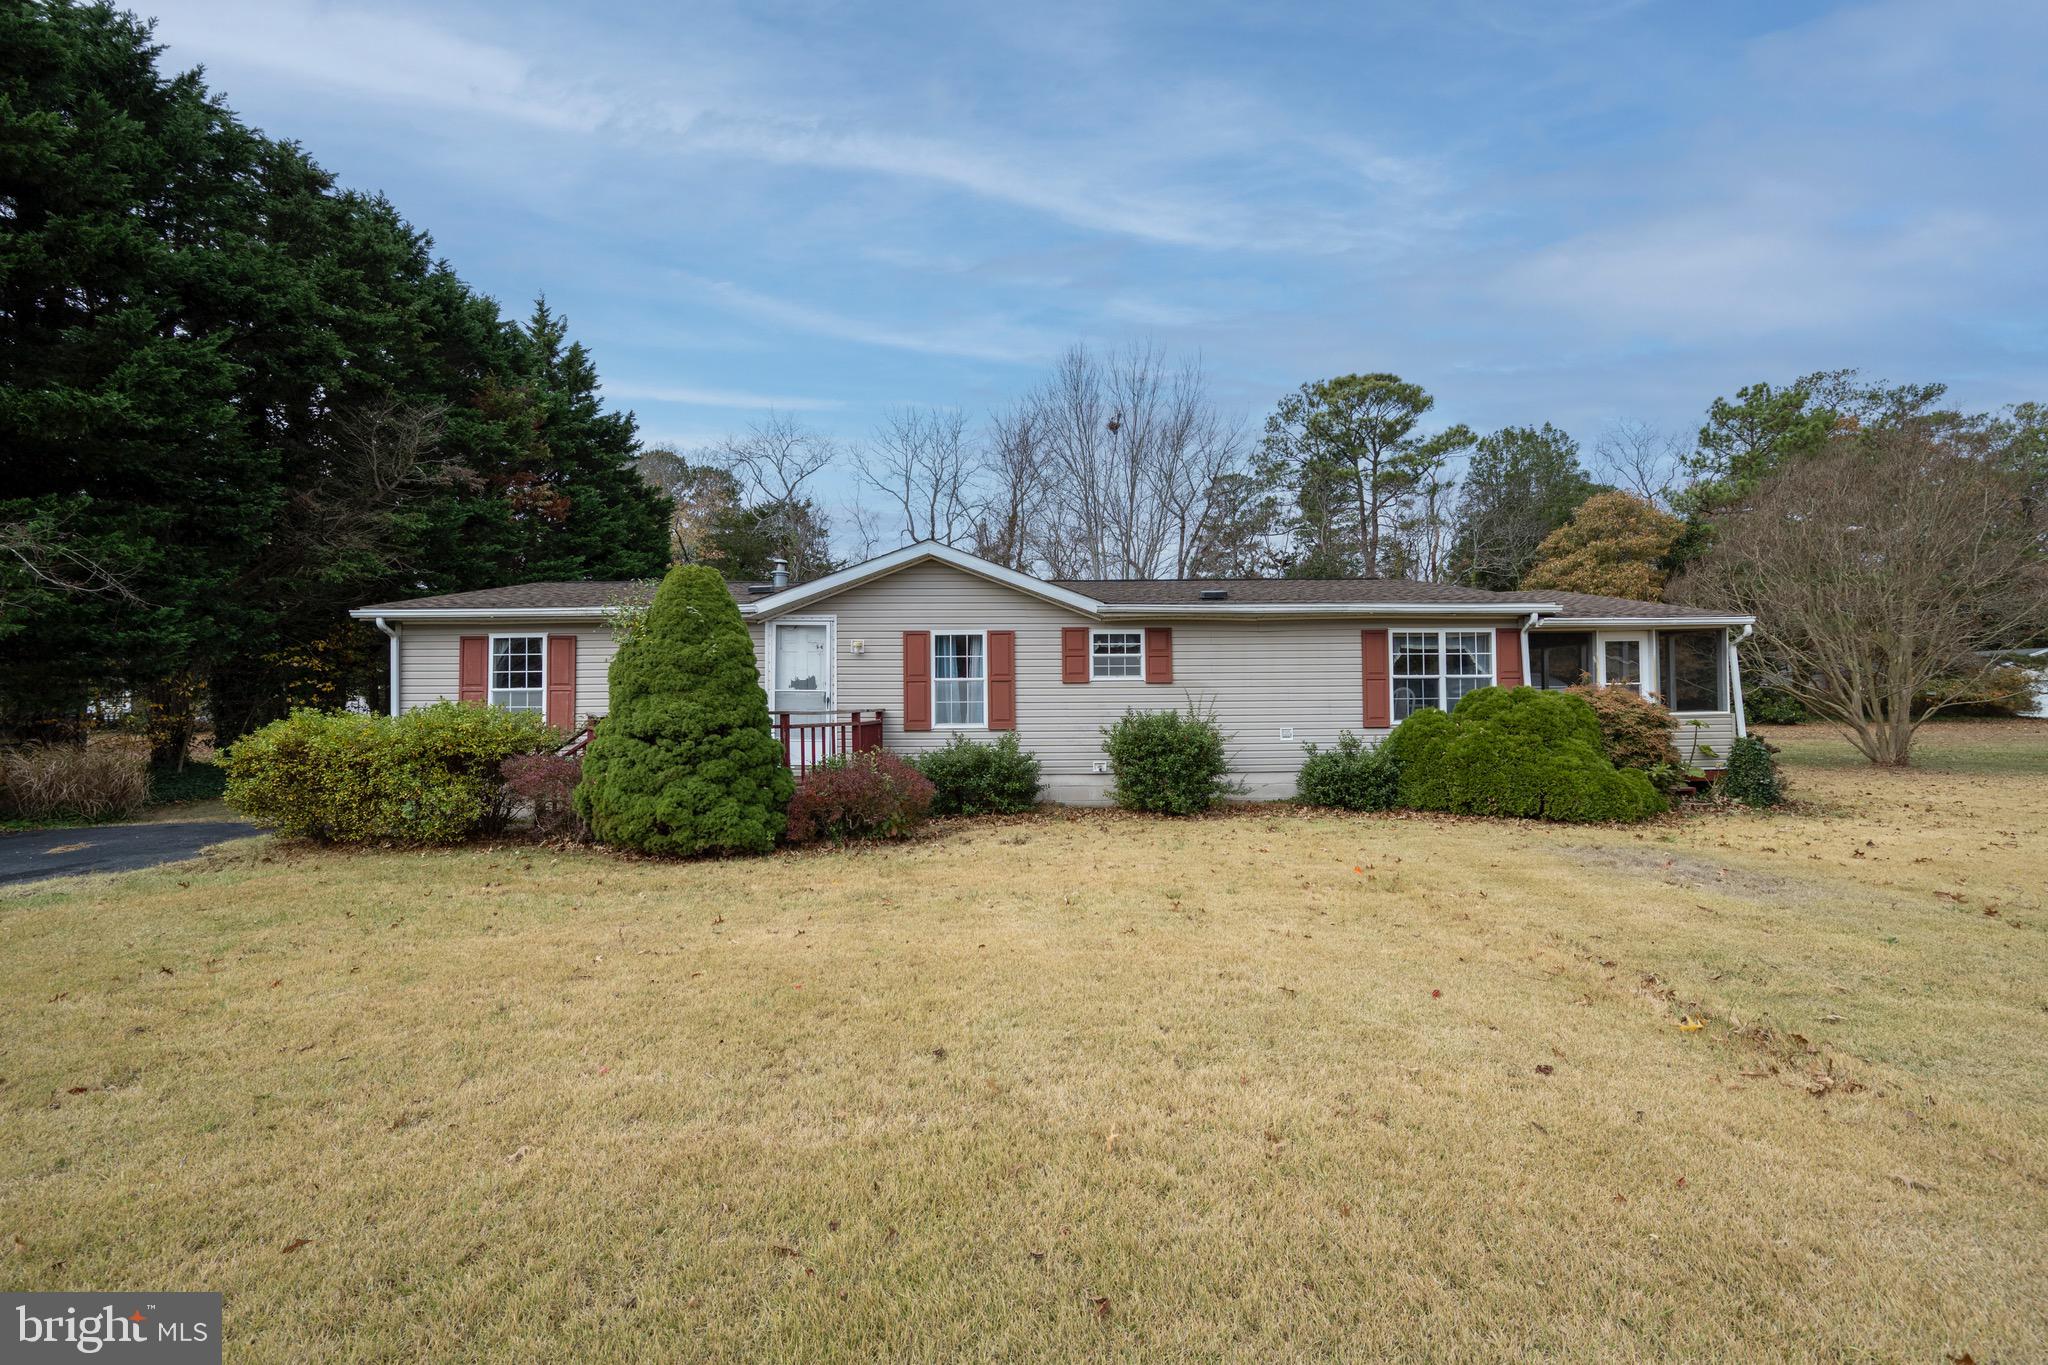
[1384, 688, 1667, 823]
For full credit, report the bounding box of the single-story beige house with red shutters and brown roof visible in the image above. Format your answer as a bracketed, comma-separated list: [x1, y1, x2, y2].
[350, 542, 1753, 804]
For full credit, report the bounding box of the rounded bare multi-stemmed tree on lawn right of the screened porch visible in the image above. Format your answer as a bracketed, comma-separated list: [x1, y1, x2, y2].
[1675, 422, 2048, 765]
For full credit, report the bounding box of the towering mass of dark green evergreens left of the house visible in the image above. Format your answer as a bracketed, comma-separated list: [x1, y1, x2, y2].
[0, 0, 668, 737]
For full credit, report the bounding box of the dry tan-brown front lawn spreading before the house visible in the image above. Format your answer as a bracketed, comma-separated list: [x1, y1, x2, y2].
[0, 724, 2048, 1361]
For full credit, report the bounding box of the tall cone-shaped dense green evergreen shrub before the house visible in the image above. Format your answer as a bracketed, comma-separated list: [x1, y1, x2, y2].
[575, 565, 795, 855]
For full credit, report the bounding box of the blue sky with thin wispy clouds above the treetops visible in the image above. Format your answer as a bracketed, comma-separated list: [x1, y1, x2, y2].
[143, 0, 2048, 515]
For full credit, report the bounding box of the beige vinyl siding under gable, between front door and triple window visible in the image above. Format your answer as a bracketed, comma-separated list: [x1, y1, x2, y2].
[750, 563, 1518, 800]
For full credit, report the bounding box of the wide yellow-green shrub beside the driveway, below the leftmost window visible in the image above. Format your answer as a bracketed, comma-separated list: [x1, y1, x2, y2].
[221, 702, 561, 843]
